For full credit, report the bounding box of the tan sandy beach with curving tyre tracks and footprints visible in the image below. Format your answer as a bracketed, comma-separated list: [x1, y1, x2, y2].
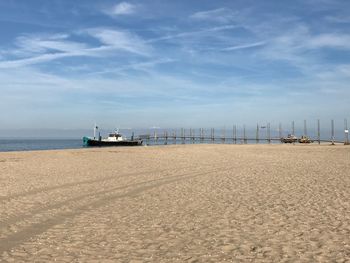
[0, 145, 350, 262]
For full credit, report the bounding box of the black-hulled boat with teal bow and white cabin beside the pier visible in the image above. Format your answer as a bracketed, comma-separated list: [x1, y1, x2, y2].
[83, 125, 142, 146]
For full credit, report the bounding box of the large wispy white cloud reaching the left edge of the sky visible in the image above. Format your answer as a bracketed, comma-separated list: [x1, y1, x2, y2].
[0, 28, 152, 68]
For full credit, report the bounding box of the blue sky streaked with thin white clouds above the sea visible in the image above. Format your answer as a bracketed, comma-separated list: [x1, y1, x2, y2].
[0, 0, 350, 130]
